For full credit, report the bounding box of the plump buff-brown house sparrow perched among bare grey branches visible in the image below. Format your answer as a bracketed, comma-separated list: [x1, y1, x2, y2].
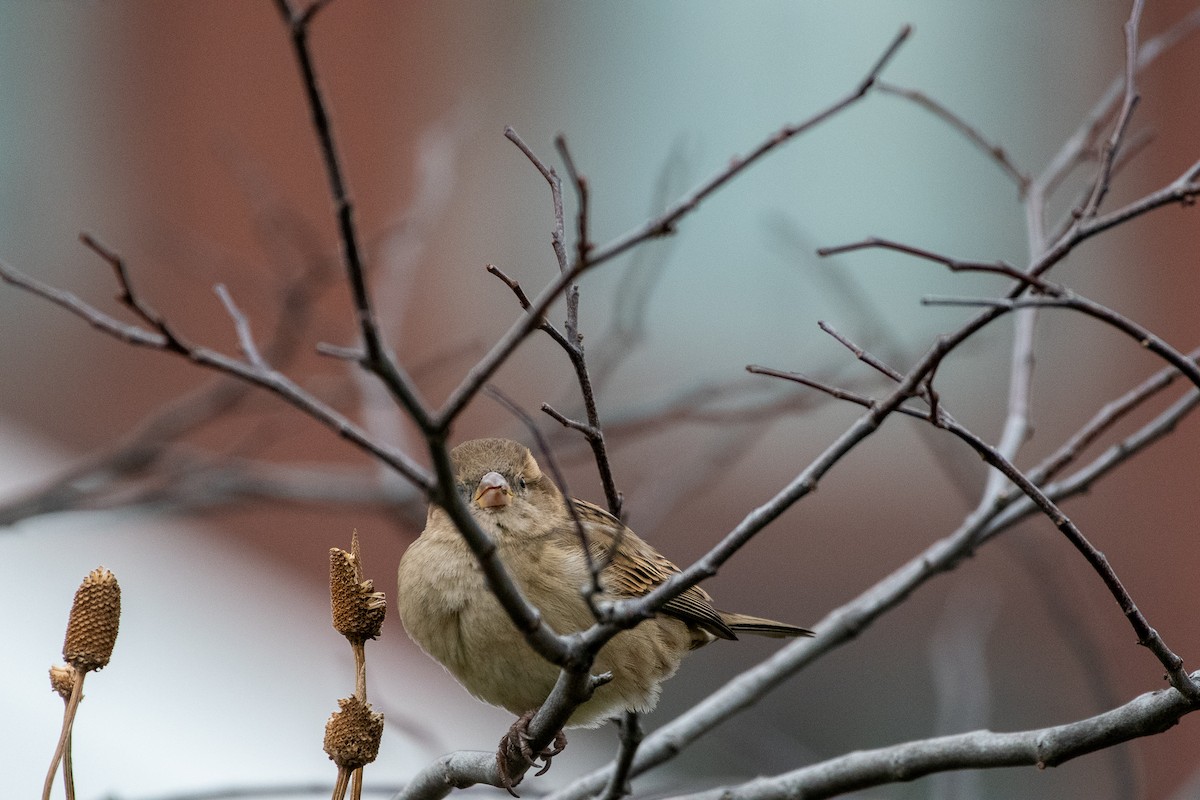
[396, 439, 812, 782]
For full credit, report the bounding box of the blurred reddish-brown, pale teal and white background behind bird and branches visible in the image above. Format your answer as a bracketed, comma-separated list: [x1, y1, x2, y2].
[0, 0, 1200, 800]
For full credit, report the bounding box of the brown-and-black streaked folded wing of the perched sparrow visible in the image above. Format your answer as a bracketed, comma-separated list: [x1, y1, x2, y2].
[572, 500, 738, 639]
